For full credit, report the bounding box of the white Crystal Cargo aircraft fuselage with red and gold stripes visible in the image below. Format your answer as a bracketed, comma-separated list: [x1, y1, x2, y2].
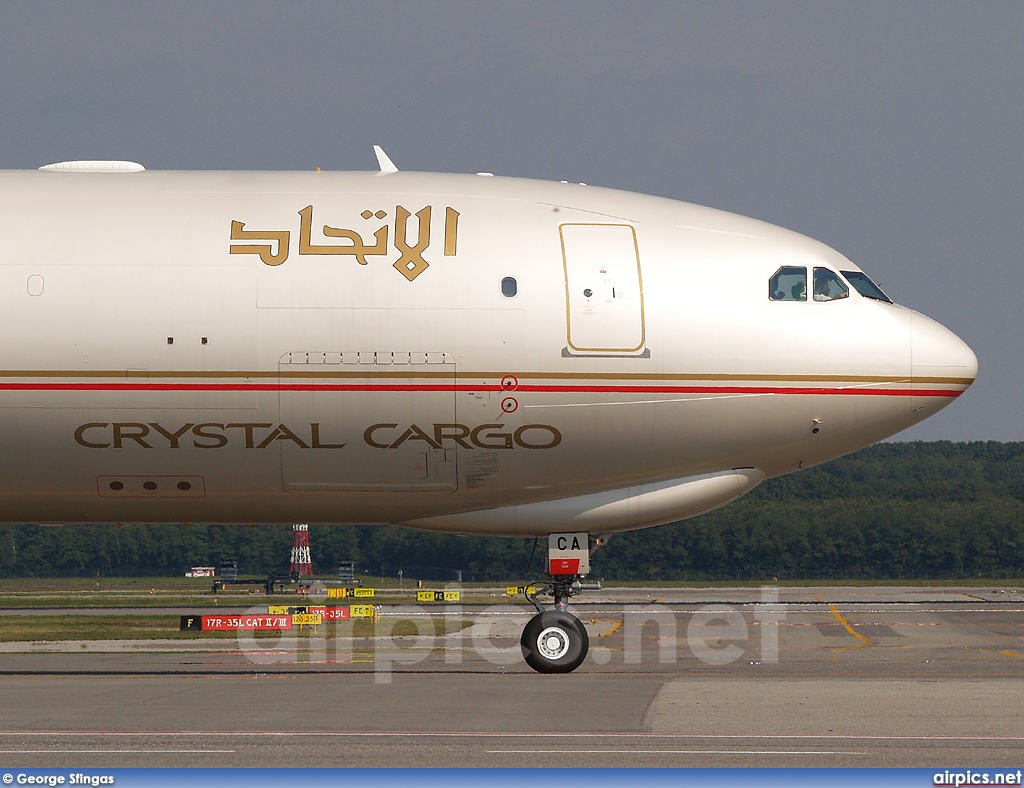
[0, 166, 977, 535]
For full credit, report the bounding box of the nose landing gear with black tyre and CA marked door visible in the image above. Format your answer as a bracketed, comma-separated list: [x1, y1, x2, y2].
[519, 533, 602, 673]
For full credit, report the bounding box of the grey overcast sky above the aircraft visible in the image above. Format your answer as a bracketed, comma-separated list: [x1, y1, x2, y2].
[0, 0, 1024, 440]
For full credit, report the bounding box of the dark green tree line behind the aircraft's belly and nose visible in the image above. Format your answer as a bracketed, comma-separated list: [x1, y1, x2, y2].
[0, 441, 1024, 581]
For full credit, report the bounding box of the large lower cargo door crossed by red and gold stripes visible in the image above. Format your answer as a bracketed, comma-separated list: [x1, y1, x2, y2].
[274, 351, 458, 492]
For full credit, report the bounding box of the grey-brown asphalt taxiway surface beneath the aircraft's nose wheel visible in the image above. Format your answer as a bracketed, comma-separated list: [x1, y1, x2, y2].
[0, 588, 1024, 769]
